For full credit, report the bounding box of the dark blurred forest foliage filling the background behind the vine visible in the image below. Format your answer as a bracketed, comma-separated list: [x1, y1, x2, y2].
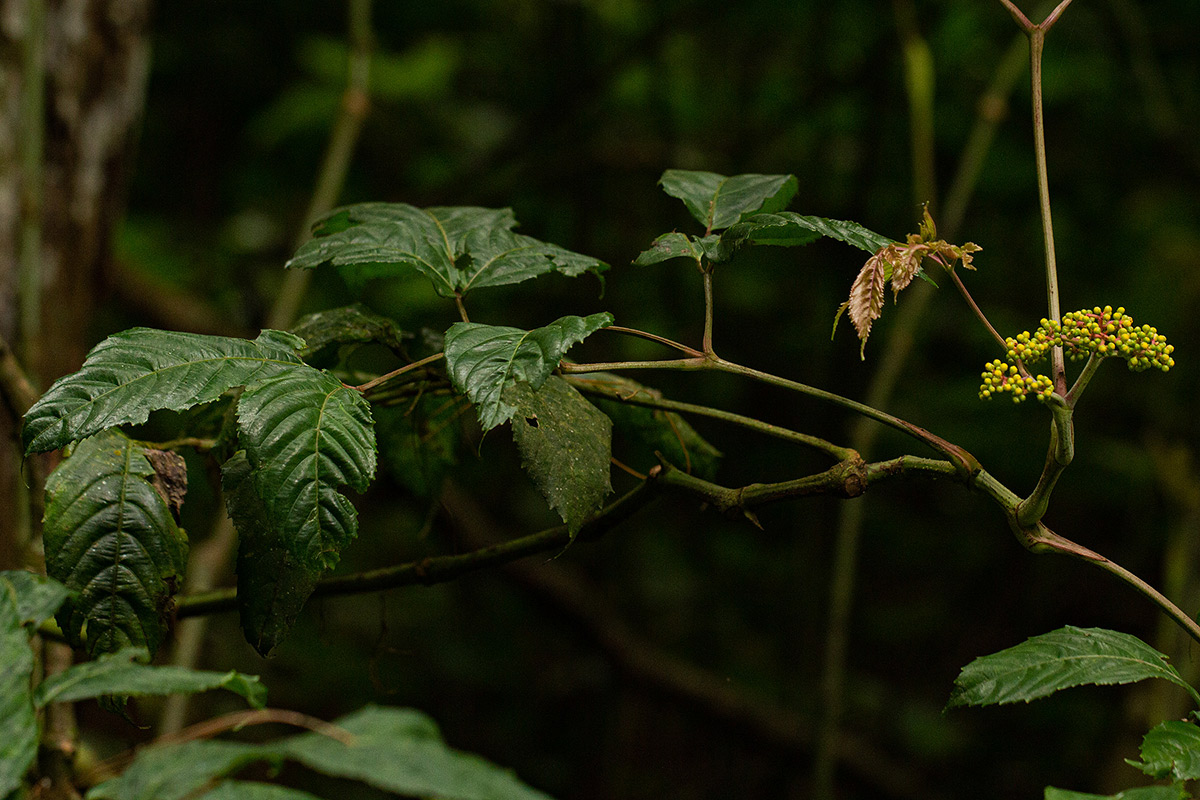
[94, 0, 1200, 800]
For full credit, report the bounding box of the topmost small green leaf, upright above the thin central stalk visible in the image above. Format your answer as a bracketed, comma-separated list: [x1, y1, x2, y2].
[659, 169, 797, 234]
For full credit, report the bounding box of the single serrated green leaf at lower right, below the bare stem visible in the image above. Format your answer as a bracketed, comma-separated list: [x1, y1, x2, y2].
[947, 625, 1200, 708]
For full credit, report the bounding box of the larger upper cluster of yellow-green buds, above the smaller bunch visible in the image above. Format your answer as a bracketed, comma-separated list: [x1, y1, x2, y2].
[1004, 306, 1175, 372]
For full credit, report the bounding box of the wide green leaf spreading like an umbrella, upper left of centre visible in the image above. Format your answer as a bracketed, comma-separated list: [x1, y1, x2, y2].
[287, 203, 608, 297]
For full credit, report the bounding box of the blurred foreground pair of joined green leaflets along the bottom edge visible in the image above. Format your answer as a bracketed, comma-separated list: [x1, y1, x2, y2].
[88, 706, 548, 800]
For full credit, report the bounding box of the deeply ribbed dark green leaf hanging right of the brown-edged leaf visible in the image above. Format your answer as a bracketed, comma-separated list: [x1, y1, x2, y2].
[238, 367, 376, 570]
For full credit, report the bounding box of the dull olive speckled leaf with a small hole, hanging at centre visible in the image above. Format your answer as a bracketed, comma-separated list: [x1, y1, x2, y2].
[505, 375, 612, 536]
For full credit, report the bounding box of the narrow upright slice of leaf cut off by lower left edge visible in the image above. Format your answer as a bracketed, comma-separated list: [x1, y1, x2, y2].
[0, 581, 37, 798]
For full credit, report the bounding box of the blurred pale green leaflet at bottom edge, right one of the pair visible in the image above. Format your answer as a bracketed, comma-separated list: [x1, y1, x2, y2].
[281, 706, 548, 800]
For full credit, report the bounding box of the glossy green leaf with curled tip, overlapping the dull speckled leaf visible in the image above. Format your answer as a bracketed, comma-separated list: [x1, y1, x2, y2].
[445, 312, 612, 432]
